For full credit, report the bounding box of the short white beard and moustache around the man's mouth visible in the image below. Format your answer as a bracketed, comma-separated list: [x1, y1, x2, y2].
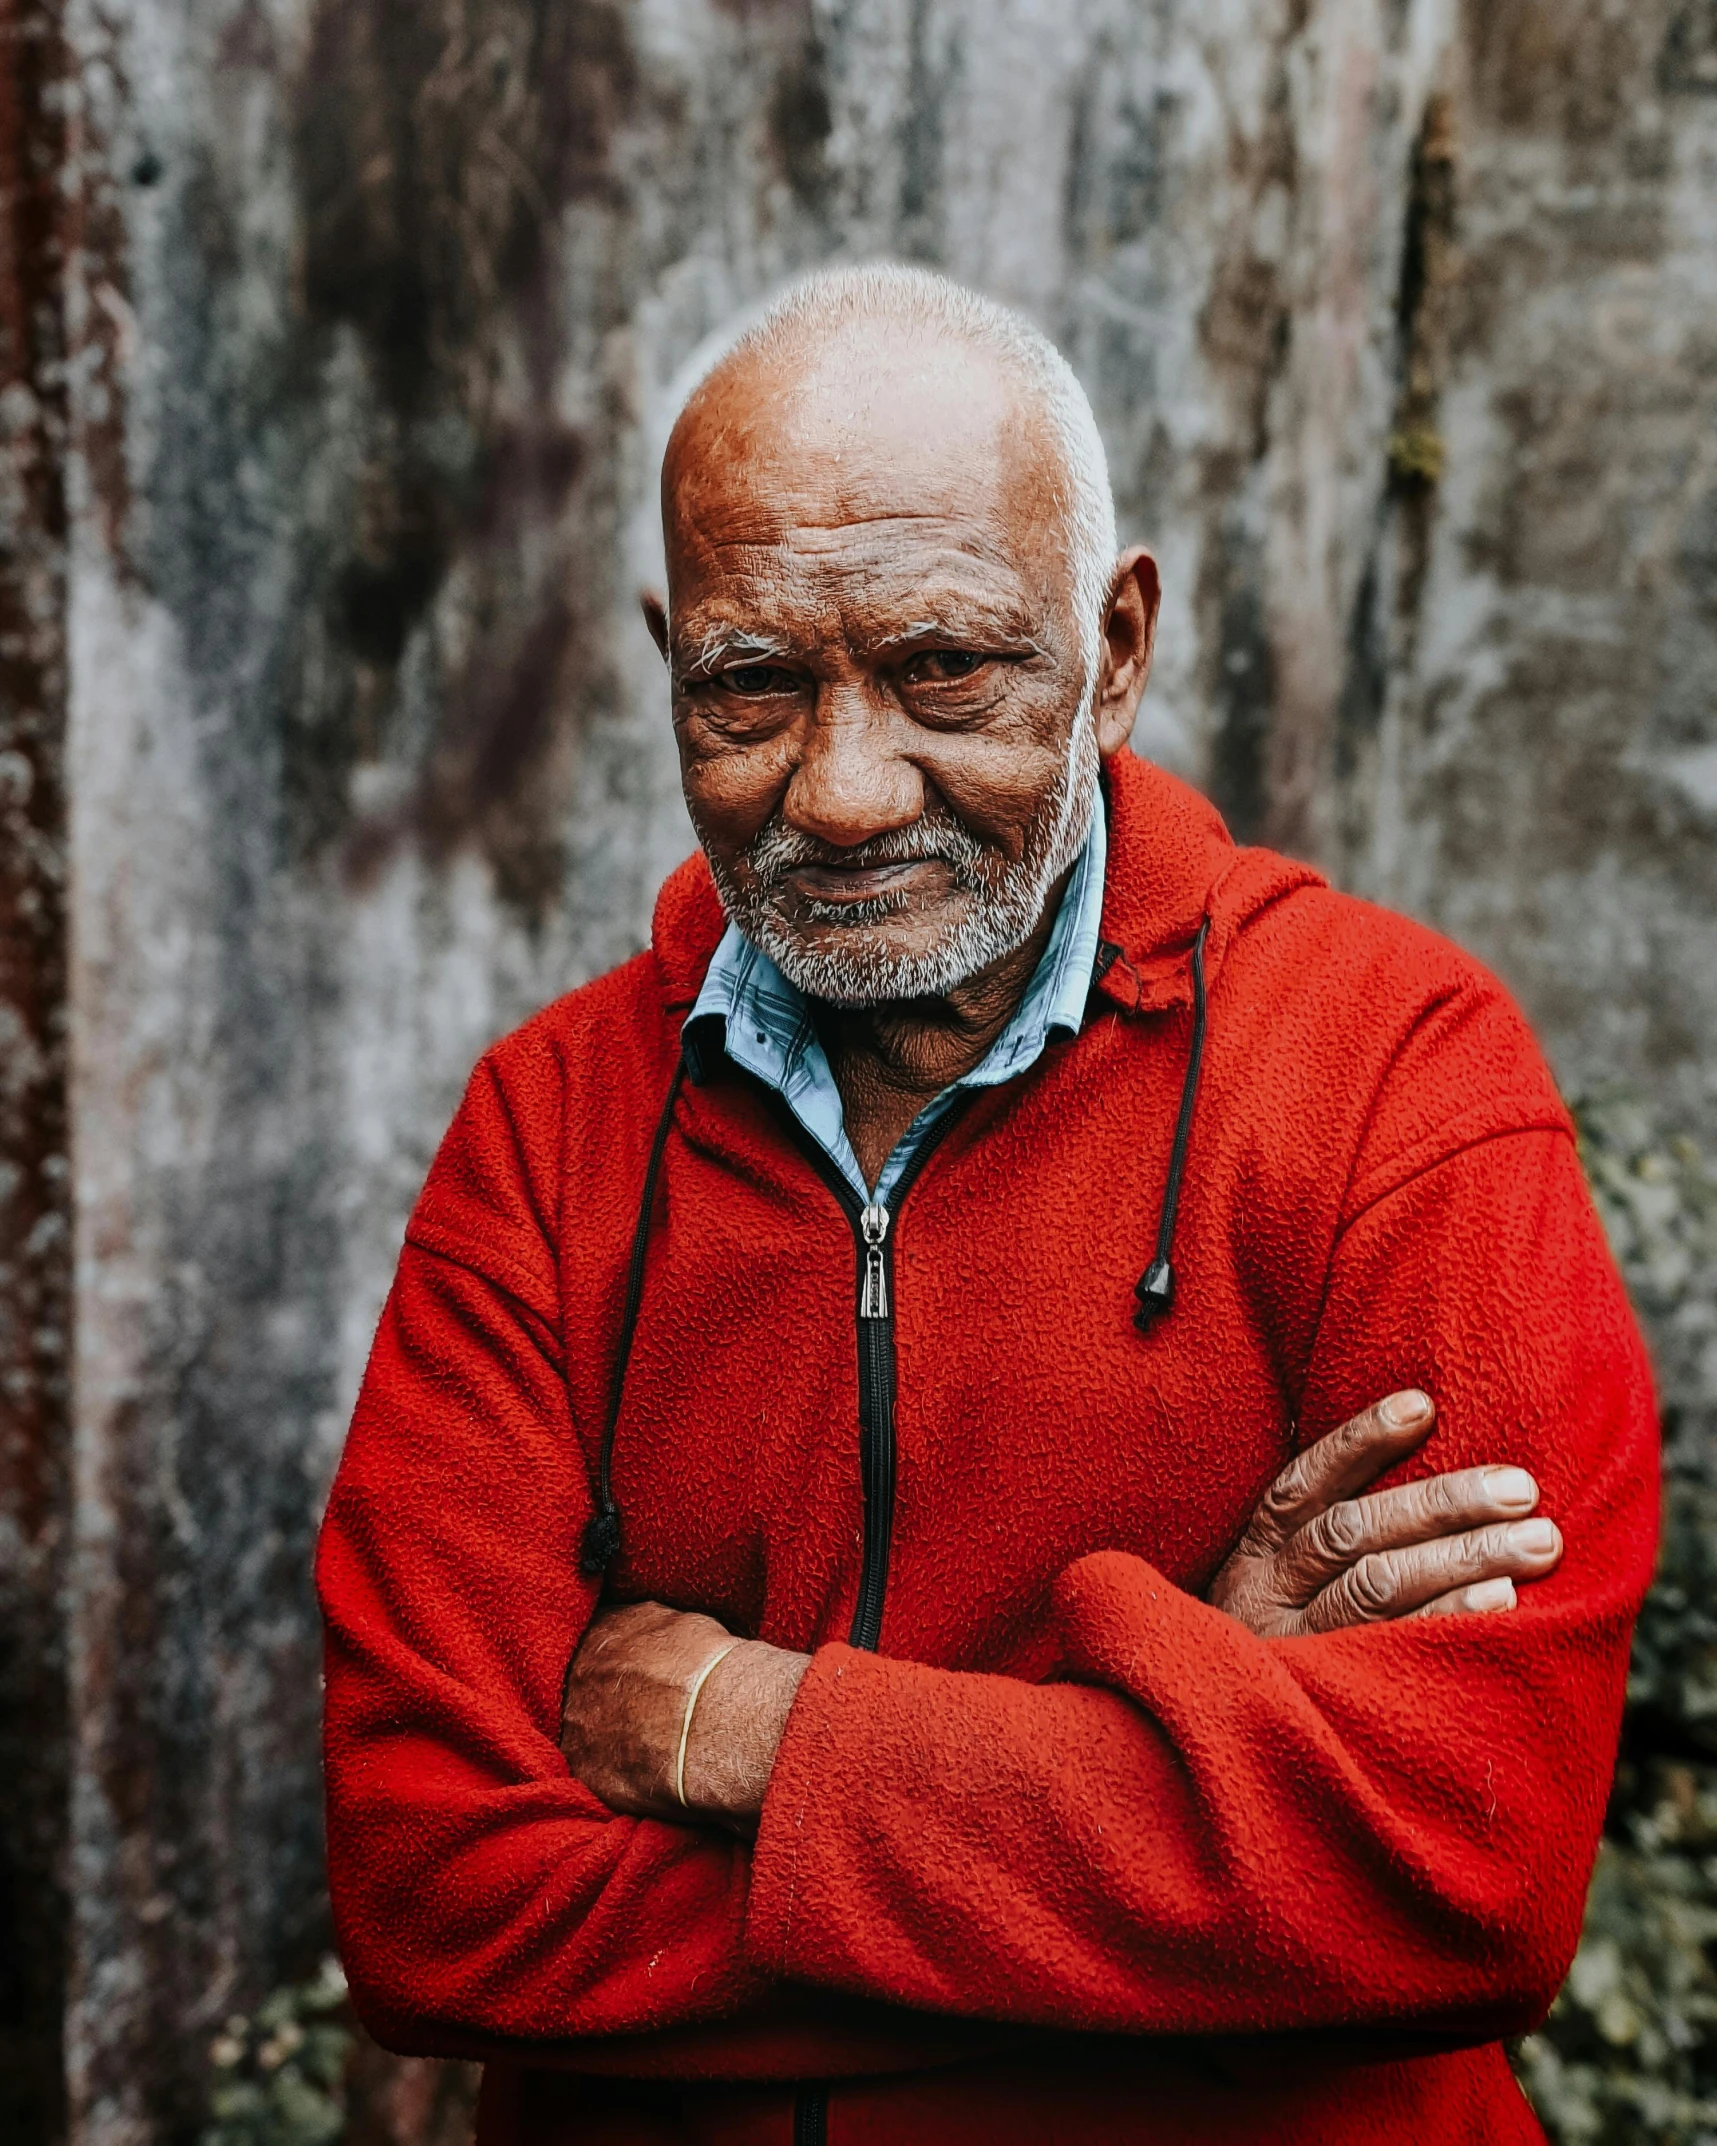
[695, 691, 1099, 1006]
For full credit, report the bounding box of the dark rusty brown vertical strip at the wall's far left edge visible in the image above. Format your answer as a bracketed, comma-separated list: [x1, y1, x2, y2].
[0, 0, 71, 2146]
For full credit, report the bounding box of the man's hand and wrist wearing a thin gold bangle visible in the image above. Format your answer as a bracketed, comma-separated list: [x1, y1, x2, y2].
[560, 1603, 811, 1833]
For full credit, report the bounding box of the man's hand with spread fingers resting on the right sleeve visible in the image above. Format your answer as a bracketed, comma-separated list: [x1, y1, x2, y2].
[1206, 1393, 1562, 1640]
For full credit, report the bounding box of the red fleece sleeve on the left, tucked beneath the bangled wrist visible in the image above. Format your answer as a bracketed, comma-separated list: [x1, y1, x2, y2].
[318, 1047, 753, 2052]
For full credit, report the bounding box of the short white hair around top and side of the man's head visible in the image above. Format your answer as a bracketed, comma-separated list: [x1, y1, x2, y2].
[672, 262, 1116, 685]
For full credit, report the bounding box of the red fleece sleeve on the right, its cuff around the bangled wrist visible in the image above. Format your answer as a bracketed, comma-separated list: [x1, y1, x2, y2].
[749, 1131, 1657, 2039]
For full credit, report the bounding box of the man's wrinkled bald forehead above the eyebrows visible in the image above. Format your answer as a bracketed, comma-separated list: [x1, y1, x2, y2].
[663, 335, 1073, 648]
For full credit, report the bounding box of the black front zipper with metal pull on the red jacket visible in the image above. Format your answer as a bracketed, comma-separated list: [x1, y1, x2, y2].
[781, 1103, 959, 1655]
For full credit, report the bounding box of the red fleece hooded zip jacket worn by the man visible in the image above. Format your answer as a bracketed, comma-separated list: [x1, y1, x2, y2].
[320, 755, 1655, 2146]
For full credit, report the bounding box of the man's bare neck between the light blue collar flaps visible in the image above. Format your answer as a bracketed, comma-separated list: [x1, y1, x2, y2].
[818, 873, 1071, 1185]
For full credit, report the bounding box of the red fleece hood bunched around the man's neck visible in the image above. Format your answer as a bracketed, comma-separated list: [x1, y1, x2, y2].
[650, 749, 1324, 1013]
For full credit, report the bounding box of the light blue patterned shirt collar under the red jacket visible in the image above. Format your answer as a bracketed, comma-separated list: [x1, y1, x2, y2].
[687, 798, 1110, 1208]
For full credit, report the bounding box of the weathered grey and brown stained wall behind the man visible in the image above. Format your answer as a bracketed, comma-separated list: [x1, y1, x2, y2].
[0, 0, 1717, 2146]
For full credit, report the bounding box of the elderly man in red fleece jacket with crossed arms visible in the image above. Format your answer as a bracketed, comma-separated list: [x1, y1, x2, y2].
[320, 270, 1655, 2146]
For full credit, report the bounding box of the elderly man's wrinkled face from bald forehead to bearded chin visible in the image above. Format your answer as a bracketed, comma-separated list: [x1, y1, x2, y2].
[663, 330, 1141, 1002]
